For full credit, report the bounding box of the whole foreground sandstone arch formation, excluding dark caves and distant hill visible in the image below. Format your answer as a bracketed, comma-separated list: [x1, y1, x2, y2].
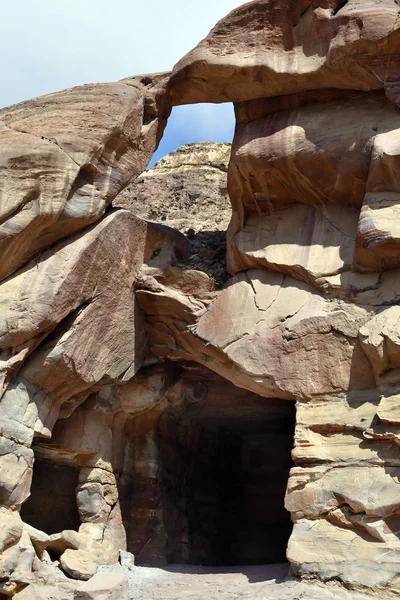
[0, 0, 400, 595]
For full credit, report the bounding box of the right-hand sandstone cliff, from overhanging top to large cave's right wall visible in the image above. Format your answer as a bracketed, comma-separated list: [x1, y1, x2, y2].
[161, 0, 400, 590]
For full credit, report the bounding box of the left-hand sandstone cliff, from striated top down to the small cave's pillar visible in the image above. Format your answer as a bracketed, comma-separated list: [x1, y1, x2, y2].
[0, 74, 170, 597]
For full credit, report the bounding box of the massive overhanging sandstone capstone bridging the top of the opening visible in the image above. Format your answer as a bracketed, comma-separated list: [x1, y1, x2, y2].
[171, 0, 400, 105]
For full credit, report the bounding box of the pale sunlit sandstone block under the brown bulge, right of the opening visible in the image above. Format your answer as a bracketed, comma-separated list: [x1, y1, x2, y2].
[231, 204, 358, 289]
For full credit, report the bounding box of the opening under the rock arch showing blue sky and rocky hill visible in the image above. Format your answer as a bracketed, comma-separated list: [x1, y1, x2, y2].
[114, 103, 234, 288]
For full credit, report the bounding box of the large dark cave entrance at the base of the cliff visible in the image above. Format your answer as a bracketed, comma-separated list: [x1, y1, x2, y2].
[159, 370, 295, 567]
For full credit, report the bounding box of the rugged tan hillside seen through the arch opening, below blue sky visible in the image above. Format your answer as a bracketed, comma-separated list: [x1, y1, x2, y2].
[114, 142, 231, 285]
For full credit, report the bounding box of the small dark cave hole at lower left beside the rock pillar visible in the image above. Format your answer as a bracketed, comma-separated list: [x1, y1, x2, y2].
[21, 458, 80, 535]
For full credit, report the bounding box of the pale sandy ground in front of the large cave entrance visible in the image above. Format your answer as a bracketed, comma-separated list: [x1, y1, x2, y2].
[101, 564, 383, 600]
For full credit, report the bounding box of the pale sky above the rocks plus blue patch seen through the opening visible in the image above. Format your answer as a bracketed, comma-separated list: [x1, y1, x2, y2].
[0, 0, 243, 164]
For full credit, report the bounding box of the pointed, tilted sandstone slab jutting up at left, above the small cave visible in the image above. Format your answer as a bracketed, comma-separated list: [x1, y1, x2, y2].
[1, 211, 146, 444]
